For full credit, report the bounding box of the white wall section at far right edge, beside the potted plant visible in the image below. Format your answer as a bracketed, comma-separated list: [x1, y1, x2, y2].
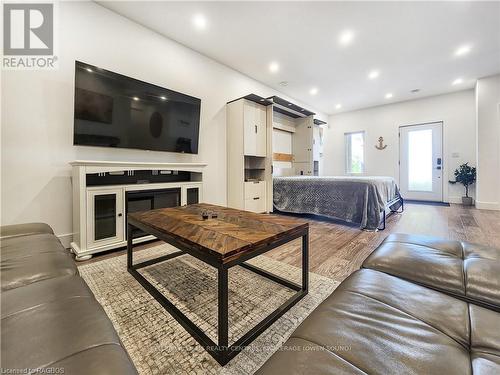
[476, 75, 500, 210]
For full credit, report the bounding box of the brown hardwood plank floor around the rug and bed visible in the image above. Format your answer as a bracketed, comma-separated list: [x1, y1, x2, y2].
[79, 204, 500, 281]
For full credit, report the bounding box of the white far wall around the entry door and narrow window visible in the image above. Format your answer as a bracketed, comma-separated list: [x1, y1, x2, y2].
[322, 90, 476, 202]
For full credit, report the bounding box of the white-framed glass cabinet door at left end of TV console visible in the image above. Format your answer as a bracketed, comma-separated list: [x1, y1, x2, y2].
[87, 189, 124, 247]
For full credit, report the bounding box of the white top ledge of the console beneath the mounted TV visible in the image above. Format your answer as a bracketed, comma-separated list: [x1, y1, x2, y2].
[69, 160, 207, 173]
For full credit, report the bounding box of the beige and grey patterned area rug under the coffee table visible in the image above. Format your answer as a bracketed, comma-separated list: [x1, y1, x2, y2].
[79, 244, 338, 374]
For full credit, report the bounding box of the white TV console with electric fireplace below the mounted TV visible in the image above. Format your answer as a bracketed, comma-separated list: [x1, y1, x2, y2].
[70, 160, 206, 260]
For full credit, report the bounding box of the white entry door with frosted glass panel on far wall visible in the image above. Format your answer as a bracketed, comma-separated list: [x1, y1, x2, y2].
[399, 122, 443, 202]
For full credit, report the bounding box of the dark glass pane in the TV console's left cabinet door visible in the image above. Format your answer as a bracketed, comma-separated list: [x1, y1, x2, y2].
[94, 194, 116, 241]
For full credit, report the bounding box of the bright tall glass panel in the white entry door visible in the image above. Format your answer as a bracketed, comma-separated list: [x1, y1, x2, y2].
[408, 129, 432, 192]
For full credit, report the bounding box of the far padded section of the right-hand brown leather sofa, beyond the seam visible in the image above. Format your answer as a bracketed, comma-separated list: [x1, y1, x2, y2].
[363, 234, 500, 309]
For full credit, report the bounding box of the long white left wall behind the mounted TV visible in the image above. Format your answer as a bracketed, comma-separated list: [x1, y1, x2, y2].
[1, 2, 325, 247]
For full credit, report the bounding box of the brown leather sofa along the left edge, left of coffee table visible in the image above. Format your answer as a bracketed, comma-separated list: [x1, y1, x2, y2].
[0, 223, 137, 375]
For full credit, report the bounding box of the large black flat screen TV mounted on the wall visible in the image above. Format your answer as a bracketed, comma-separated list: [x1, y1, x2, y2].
[73, 61, 201, 154]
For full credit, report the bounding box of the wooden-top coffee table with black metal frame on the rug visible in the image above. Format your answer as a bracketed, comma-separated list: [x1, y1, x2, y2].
[127, 204, 309, 365]
